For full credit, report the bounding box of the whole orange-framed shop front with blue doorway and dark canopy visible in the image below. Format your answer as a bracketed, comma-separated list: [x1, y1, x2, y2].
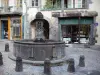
[0, 14, 22, 40]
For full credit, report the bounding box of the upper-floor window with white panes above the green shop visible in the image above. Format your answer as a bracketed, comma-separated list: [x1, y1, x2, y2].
[64, 0, 86, 8]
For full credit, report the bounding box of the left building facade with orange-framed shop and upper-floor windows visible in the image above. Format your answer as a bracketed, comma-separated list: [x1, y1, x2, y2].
[0, 0, 22, 40]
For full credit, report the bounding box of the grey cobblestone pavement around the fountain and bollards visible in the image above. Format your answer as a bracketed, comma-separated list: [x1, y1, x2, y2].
[0, 40, 100, 75]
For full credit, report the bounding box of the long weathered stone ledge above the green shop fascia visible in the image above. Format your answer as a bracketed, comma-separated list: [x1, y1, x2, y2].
[52, 11, 97, 17]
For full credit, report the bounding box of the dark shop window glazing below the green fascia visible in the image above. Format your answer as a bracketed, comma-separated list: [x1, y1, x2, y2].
[61, 25, 90, 43]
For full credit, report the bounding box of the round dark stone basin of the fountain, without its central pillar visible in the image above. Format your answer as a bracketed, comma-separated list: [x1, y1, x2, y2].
[13, 40, 65, 61]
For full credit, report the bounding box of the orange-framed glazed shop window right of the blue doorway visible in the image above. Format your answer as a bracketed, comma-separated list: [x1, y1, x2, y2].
[10, 17, 22, 40]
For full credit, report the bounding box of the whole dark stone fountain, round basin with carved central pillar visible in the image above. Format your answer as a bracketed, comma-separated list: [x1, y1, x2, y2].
[10, 12, 65, 64]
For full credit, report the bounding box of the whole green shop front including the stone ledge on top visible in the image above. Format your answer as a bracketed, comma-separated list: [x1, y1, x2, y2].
[52, 10, 98, 45]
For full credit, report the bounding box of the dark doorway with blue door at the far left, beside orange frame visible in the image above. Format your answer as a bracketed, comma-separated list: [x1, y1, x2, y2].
[1, 20, 8, 39]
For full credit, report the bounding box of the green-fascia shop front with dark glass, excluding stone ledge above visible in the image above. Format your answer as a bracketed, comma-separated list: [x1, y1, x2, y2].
[59, 17, 93, 43]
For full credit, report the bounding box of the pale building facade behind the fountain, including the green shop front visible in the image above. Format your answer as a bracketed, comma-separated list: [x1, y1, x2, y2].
[23, 0, 100, 44]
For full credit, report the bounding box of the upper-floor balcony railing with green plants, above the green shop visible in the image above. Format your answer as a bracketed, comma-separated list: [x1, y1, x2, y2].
[41, 0, 87, 10]
